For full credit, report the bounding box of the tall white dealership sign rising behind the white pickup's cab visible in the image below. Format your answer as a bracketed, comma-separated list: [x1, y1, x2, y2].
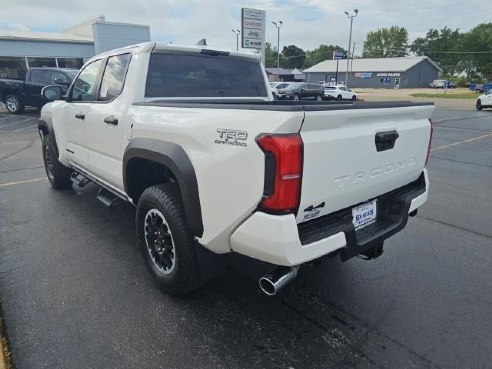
[241, 8, 265, 50]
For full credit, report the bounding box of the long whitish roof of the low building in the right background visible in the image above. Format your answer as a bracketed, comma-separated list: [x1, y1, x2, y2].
[304, 56, 441, 73]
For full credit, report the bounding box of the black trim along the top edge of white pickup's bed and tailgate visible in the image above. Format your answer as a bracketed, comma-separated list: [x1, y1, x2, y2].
[133, 98, 434, 111]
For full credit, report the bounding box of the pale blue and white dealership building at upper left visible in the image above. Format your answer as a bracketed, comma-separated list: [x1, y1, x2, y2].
[0, 16, 150, 79]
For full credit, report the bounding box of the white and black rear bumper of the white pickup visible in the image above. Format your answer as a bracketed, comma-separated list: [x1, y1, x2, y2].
[231, 169, 429, 266]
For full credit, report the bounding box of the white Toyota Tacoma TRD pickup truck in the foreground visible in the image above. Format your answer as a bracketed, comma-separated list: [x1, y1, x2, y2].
[39, 43, 433, 295]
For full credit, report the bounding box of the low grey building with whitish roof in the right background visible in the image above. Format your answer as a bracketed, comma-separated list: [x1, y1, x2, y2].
[304, 56, 442, 88]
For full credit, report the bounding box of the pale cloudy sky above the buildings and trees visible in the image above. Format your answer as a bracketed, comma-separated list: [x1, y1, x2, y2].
[0, 0, 492, 54]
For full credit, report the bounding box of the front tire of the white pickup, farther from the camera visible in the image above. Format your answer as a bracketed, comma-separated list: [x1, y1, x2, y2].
[42, 135, 72, 190]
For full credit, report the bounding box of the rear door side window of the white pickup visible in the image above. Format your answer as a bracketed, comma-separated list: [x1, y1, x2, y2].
[97, 54, 130, 101]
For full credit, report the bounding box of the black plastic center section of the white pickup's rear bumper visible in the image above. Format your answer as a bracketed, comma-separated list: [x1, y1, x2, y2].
[297, 173, 425, 261]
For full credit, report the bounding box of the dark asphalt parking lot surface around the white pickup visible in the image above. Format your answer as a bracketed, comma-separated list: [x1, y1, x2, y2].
[0, 109, 492, 369]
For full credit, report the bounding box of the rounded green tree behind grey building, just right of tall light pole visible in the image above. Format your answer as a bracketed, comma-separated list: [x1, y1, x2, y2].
[362, 26, 408, 58]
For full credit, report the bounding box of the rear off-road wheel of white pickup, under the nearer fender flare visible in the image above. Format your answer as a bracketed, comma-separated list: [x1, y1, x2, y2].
[136, 183, 204, 295]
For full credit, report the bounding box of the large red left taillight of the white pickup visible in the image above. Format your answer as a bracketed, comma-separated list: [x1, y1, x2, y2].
[256, 133, 303, 212]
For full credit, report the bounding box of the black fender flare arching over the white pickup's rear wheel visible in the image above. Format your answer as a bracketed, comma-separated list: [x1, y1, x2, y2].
[123, 138, 203, 237]
